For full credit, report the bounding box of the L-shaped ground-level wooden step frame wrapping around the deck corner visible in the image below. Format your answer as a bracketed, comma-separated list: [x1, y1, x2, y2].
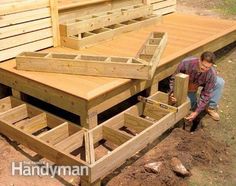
[0, 73, 190, 183]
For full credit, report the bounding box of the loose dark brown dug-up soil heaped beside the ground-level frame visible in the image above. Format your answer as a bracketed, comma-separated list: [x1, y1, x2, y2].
[108, 128, 231, 186]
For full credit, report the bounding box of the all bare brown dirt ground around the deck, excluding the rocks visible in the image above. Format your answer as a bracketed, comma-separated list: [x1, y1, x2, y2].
[0, 0, 236, 186]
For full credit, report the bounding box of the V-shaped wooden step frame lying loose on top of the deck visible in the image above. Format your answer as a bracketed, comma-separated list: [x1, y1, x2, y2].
[16, 32, 167, 80]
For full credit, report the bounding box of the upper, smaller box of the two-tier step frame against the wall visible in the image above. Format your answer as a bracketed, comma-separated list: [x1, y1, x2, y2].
[60, 5, 152, 36]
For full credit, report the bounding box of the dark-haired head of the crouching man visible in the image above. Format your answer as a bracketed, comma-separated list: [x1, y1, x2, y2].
[199, 51, 215, 72]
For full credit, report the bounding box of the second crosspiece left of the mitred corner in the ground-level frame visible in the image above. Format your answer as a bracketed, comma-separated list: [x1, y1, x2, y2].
[38, 122, 69, 145]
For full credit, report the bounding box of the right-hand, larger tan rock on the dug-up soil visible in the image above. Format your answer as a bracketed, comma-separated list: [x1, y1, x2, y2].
[171, 157, 190, 177]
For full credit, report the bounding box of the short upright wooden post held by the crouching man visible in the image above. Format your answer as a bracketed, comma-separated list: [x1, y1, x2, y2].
[174, 73, 189, 106]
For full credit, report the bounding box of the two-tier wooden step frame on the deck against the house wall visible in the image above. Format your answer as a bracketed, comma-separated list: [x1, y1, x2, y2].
[60, 4, 160, 49]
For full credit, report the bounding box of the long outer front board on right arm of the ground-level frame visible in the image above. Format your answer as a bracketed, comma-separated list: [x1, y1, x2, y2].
[90, 113, 177, 182]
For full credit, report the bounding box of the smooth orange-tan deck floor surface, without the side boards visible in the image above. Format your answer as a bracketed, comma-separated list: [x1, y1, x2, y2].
[0, 13, 236, 101]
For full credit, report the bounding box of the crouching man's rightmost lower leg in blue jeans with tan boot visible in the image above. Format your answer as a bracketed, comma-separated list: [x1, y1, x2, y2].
[207, 76, 225, 121]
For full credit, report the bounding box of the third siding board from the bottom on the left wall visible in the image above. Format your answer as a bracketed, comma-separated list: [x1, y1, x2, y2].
[0, 18, 52, 39]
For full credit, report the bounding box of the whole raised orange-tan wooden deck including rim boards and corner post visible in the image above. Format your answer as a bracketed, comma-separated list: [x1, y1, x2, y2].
[0, 13, 236, 128]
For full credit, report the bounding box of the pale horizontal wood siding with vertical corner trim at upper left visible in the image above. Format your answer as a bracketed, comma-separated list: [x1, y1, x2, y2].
[0, 0, 59, 61]
